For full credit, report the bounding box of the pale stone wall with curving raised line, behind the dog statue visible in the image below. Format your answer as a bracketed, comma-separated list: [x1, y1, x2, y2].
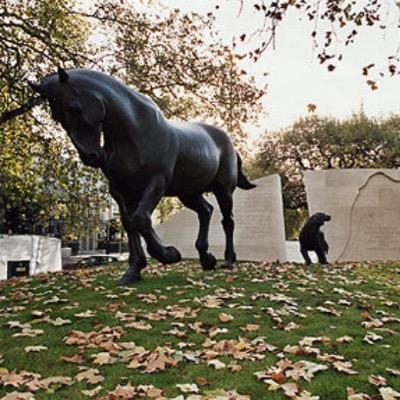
[305, 169, 400, 262]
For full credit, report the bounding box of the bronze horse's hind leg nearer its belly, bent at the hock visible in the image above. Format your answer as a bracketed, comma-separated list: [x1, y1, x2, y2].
[179, 194, 217, 270]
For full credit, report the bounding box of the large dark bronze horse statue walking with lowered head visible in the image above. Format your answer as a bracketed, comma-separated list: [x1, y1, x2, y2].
[30, 68, 255, 284]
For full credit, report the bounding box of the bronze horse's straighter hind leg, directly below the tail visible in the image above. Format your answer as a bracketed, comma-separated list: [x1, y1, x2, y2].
[214, 188, 236, 268]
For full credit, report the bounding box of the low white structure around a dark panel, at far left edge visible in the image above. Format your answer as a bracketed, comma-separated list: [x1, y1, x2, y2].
[0, 235, 62, 280]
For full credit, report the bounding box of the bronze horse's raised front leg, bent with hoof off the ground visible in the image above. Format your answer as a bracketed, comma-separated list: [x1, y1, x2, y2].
[130, 175, 181, 264]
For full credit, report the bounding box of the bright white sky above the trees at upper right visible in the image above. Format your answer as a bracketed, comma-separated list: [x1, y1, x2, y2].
[161, 0, 400, 136]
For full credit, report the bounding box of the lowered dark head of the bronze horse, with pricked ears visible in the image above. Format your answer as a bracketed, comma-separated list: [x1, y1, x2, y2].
[30, 68, 106, 167]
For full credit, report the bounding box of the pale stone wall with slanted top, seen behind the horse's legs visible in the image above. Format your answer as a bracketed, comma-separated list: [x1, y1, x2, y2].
[156, 175, 286, 262]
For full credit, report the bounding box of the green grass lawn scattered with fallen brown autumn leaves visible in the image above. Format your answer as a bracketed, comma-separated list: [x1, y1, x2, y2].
[0, 261, 400, 400]
